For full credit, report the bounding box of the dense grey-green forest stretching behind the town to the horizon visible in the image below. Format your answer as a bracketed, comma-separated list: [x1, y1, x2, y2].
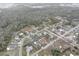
[0, 4, 79, 52]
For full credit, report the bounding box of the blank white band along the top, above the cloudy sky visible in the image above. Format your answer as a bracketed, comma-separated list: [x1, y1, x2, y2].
[0, 0, 79, 3]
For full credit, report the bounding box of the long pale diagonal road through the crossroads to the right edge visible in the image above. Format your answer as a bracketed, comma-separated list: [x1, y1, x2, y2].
[32, 25, 79, 55]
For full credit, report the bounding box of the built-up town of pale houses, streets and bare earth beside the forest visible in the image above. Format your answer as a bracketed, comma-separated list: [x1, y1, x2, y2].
[7, 16, 79, 56]
